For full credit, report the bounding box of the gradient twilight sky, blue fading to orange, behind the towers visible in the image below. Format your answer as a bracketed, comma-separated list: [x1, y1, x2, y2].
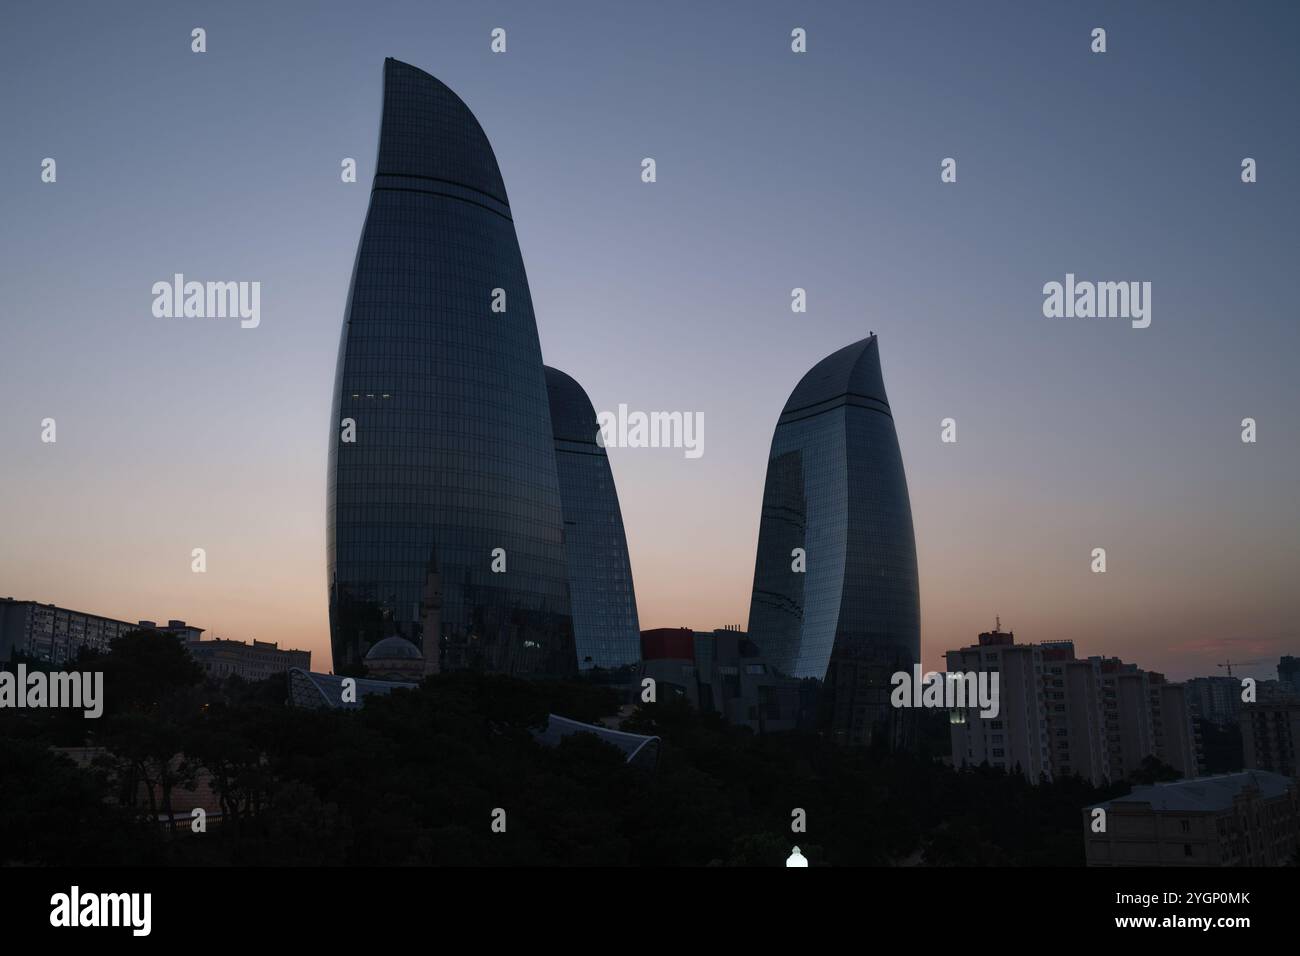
[0, 0, 1300, 678]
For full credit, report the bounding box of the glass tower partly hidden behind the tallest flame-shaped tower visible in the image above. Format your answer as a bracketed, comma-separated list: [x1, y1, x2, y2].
[546, 365, 641, 670]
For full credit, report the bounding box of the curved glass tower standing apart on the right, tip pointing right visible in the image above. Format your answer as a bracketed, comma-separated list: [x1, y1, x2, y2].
[749, 336, 920, 747]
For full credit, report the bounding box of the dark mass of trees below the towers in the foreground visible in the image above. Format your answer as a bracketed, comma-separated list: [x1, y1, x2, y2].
[0, 633, 1133, 866]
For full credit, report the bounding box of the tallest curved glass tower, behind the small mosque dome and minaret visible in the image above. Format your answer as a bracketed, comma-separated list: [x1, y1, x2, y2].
[326, 60, 576, 676]
